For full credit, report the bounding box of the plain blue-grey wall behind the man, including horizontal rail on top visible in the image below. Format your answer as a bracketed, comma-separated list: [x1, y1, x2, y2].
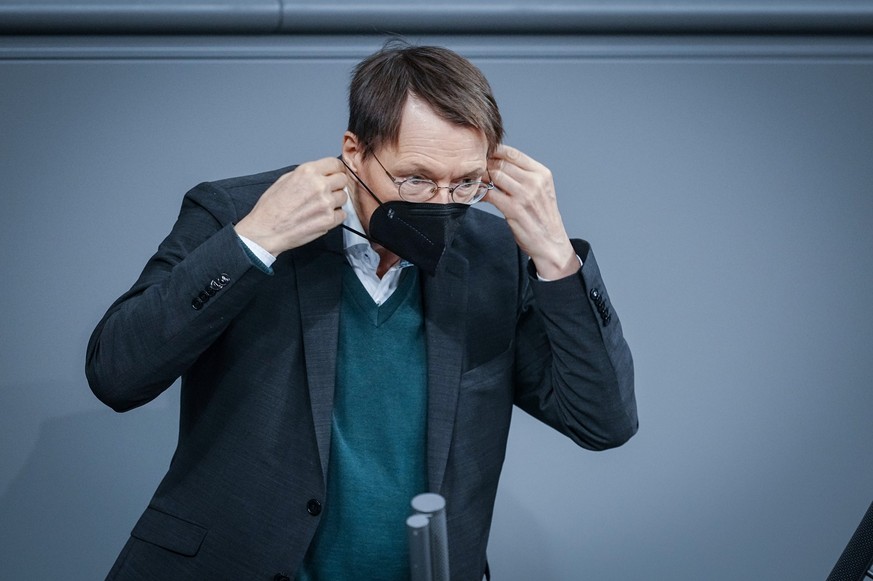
[0, 2, 873, 581]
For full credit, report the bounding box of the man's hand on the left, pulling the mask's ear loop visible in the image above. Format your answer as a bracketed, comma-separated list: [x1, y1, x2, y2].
[234, 157, 349, 256]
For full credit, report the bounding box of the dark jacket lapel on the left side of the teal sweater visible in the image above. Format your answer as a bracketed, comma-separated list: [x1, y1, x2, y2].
[293, 228, 345, 482]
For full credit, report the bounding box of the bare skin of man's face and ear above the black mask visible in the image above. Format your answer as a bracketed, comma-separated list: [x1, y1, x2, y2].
[343, 96, 488, 231]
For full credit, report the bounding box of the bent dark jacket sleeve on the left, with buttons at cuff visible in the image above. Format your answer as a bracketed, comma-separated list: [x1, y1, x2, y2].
[85, 184, 266, 411]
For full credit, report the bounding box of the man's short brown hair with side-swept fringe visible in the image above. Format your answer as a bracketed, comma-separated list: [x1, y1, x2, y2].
[348, 40, 503, 156]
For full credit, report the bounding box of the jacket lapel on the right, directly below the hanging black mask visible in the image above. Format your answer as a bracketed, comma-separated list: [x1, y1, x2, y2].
[422, 252, 469, 492]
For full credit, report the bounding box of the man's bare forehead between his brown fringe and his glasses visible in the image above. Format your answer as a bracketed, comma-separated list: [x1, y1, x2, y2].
[379, 96, 488, 172]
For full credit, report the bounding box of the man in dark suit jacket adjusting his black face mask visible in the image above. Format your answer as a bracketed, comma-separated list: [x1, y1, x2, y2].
[87, 45, 637, 580]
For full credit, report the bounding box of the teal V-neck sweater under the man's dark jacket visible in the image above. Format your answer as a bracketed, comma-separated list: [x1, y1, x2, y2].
[298, 267, 427, 581]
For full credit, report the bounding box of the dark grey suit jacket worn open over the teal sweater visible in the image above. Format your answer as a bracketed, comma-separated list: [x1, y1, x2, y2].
[87, 168, 637, 581]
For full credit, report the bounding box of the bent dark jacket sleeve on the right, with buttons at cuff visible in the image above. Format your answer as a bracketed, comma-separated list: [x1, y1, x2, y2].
[515, 240, 638, 450]
